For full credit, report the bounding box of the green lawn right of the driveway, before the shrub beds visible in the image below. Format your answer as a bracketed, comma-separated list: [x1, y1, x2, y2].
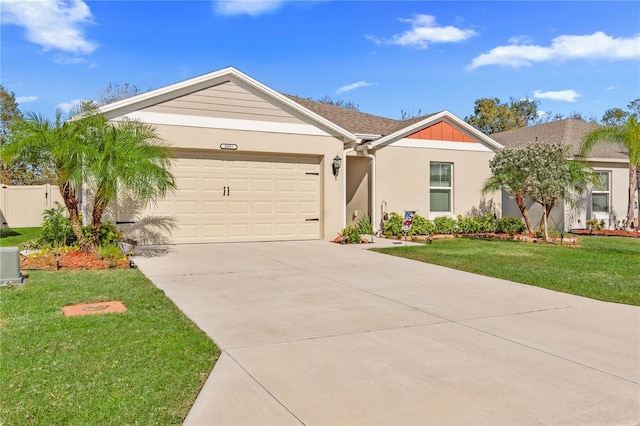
[375, 237, 640, 305]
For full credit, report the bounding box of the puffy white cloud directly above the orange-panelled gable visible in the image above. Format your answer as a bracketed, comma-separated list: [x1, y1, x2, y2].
[367, 15, 477, 49]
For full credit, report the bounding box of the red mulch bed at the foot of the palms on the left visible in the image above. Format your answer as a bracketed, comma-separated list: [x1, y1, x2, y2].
[20, 251, 129, 271]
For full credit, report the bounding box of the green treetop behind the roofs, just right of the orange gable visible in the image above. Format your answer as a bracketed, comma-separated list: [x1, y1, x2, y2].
[464, 98, 539, 135]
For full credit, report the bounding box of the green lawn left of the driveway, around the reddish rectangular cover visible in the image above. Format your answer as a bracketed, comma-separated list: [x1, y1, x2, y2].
[0, 270, 219, 425]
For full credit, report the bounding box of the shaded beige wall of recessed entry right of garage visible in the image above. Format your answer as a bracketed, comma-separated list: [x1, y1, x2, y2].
[345, 153, 371, 226]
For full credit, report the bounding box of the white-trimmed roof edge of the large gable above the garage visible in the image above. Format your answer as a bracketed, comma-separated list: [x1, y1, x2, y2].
[100, 67, 357, 142]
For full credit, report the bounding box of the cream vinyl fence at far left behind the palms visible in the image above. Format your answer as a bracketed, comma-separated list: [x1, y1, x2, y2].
[0, 184, 64, 228]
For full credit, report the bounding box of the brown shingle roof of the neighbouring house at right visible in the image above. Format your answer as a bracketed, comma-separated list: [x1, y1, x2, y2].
[491, 118, 629, 160]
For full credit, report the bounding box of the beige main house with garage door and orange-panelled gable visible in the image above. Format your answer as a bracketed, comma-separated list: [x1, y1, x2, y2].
[97, 68, 501, 243]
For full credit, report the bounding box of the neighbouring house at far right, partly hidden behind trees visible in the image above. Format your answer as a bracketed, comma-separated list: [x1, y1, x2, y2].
[491, 119, 629, 230]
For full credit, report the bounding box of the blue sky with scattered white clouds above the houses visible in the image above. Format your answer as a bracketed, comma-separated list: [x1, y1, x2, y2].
[0, 0, 640, 118]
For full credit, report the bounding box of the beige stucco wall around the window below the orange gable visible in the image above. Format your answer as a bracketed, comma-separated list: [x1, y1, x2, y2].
[376, 145, 500, 219]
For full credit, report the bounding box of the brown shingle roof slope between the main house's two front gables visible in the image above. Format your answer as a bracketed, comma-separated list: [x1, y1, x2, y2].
[285, 95, 436, 136]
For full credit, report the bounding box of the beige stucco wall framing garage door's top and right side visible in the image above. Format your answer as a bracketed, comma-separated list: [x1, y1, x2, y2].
[133, 125, 345, 239]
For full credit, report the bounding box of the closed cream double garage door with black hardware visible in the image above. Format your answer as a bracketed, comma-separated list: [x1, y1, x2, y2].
[153, 154, 321, 243]
